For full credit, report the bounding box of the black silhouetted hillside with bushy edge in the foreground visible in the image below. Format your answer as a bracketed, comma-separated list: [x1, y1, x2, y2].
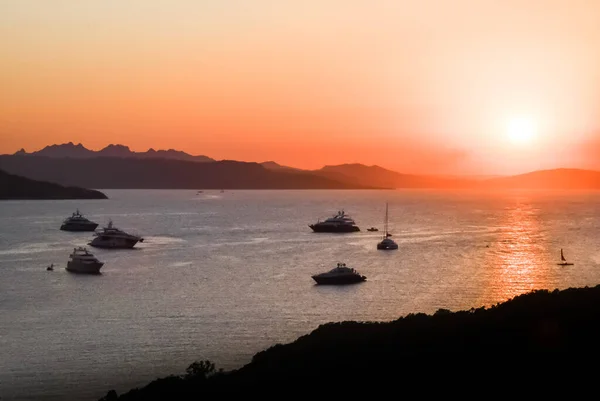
[103, 286, 600, 401]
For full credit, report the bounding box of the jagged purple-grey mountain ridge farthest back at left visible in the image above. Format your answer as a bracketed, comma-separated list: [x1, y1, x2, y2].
[15, 142, 214, 162]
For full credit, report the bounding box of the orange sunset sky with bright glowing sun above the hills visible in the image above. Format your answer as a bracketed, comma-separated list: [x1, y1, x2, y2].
[0, 0, 600, 175]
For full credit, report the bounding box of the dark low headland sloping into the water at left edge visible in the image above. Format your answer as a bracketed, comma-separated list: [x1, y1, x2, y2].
[0, 170, 107, 200]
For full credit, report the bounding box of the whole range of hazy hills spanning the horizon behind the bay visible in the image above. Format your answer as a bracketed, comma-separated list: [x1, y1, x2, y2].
[0, 142, 600, 190]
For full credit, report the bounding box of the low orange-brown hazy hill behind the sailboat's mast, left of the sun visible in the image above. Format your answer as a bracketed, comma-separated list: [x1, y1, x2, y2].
[314, 163, 475, 188]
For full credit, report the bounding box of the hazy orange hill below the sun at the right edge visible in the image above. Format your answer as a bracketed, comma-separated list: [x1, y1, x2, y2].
[483, 168, 600, 190]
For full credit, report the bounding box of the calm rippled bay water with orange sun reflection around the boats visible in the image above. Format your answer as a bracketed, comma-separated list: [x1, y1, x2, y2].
[0, 191, 600, 401]
